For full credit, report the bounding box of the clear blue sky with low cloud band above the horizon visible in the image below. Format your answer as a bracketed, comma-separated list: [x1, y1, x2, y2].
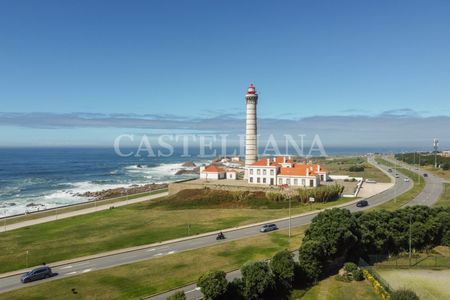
[0, 0, 450, 148]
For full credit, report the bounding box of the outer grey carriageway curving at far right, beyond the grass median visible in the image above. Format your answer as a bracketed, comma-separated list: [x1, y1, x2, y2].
[383, 157, 446, 206]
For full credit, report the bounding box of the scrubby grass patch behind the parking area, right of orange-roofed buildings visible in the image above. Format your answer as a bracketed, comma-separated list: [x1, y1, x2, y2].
[313, 157, 391, 182]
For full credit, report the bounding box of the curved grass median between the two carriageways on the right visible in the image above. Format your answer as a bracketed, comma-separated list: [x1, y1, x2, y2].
[373, 158, 425, 211]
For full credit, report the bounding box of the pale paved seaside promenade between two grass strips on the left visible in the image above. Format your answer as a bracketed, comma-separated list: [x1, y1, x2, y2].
[0, 192, 168, 232]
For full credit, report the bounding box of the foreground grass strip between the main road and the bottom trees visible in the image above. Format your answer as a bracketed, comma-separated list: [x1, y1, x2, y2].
[0, 227, 305, 300]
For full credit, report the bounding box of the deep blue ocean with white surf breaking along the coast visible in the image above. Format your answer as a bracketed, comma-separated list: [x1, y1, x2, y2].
[0, 147, 410, 217]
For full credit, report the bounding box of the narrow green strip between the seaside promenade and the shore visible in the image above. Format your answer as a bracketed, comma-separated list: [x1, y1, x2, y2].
[6, 189, 167, 224]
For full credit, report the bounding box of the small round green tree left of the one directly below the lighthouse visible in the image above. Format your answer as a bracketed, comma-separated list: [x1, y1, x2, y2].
[197, 271, 228, 300]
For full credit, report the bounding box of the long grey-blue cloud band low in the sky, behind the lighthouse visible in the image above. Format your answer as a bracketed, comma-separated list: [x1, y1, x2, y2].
[0, 109, 450, 145]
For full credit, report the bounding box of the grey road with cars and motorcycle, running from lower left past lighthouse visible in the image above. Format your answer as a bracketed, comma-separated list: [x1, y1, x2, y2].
[0, 158, 412, 292]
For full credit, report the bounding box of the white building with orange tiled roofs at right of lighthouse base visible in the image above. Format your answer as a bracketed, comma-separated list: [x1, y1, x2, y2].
[246, 156, 328, 187]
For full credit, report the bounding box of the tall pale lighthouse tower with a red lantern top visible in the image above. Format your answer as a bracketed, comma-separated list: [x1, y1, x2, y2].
[245, 84, 258, 166]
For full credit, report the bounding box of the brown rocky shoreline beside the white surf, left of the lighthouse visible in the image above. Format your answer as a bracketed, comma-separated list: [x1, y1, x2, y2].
[75, 183, 168, 201]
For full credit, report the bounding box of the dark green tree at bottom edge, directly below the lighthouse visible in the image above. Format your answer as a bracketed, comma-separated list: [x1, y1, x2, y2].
[241, 261, 275, 300]
